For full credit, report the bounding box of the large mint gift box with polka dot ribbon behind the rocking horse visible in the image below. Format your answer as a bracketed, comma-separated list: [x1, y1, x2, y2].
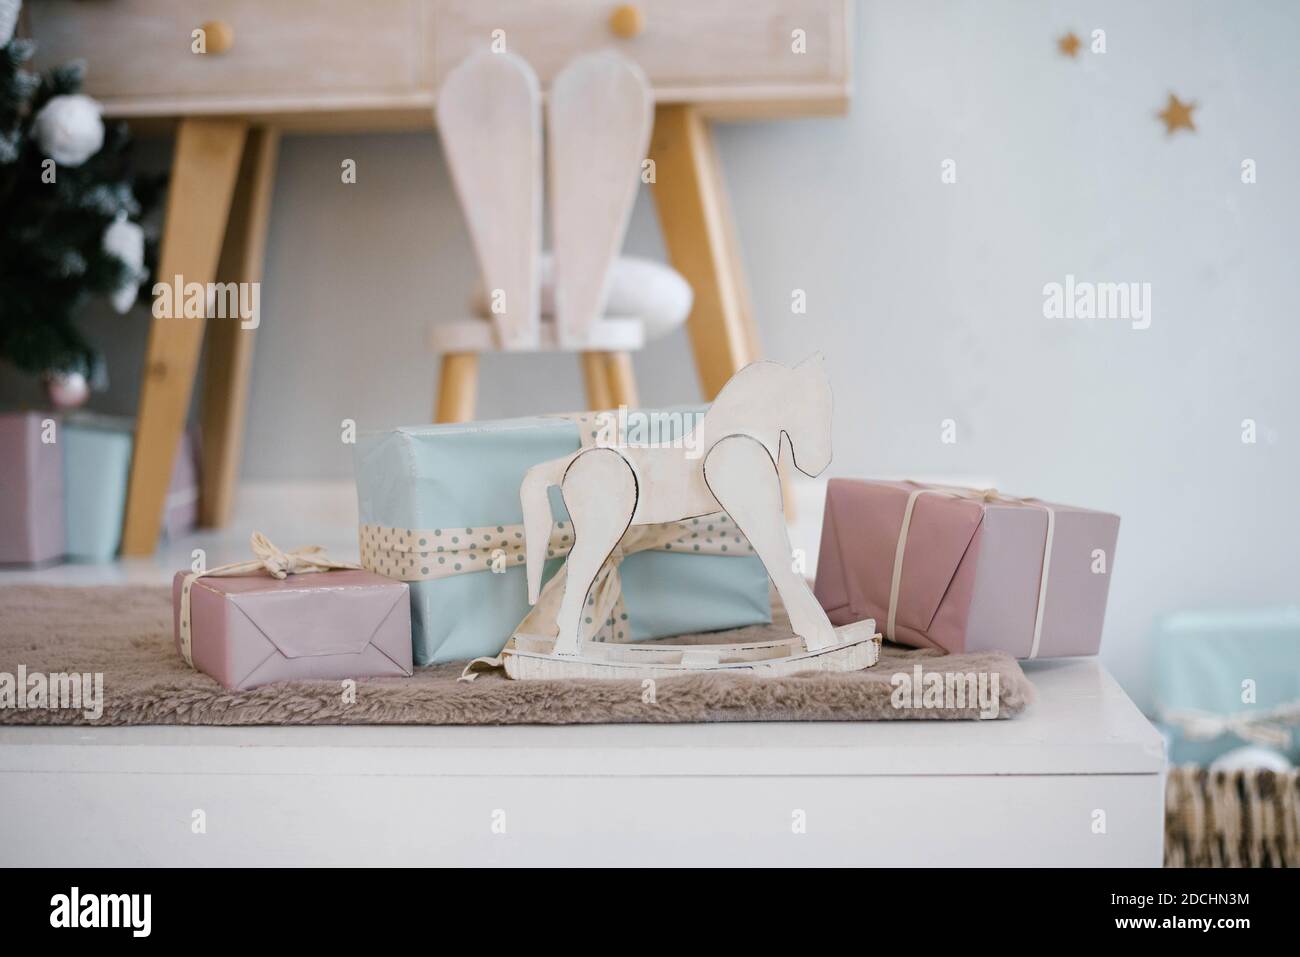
[354, 411, 771, 664]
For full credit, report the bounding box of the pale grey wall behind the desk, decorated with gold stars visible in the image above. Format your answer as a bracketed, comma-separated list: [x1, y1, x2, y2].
[7, 0, 1300, 701]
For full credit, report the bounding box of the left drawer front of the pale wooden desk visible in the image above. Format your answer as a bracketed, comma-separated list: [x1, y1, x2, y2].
[26, 0, 428, 100]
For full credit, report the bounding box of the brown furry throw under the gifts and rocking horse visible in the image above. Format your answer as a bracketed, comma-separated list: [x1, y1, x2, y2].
[0, 585, 1034, 724]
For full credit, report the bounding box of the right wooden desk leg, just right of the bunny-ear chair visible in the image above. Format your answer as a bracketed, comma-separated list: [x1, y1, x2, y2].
[650, 104, 758, 402]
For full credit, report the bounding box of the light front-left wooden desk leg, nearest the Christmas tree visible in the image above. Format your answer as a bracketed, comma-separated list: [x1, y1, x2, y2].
[122, 118, 248, 555]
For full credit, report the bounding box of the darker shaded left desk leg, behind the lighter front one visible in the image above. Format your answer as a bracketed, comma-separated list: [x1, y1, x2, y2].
[199, 127, 280, 527]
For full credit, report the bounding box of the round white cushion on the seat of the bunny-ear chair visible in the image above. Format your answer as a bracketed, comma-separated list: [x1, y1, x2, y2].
[469, 252, 694, 348]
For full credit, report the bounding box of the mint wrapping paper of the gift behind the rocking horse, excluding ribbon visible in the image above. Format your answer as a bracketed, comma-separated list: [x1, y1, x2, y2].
[354, 410, 771, 664]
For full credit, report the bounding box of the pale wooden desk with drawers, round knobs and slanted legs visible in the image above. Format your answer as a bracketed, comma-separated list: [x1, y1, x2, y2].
[23, 0, 852, 555]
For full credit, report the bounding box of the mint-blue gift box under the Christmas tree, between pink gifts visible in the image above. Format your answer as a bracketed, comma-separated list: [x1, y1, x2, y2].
[59, 412, 134, 562]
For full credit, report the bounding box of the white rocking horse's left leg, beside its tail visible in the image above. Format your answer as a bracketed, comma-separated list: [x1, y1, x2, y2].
[555, 449, 637, 654]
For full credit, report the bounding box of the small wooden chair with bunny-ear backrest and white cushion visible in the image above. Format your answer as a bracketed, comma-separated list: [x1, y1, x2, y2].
[430, 51, 692, 421]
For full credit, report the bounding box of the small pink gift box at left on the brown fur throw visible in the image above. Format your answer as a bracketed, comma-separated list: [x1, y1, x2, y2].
[172, 570, 411, 690]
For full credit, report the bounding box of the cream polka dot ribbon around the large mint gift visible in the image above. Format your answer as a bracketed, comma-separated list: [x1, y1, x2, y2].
[361, 512, 754, 641]
